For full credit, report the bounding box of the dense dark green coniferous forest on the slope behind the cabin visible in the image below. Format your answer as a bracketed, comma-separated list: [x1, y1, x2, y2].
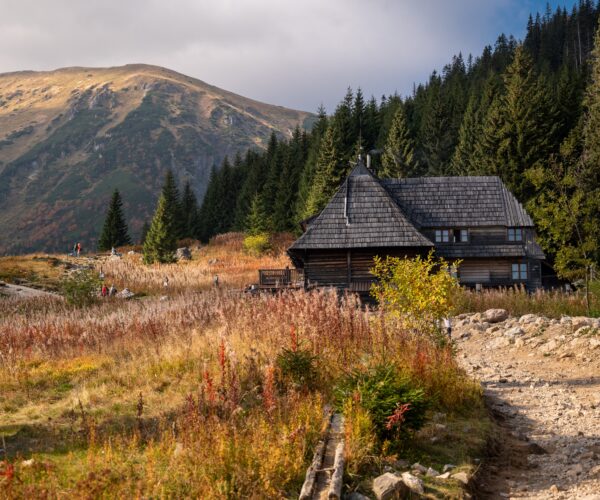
[197, 0, 600, 277]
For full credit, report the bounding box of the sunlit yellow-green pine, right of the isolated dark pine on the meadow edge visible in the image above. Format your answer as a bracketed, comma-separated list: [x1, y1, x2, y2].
[143, 193, 177, 264]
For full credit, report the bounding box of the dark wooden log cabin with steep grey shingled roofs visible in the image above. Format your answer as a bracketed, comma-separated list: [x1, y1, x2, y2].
[288, 159, 544, 293]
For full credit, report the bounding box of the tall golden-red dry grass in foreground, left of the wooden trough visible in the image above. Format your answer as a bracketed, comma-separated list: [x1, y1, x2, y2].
[0, 290, 477, 498]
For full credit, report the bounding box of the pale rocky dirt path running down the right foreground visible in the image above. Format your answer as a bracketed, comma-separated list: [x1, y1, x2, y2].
[453, 314, 600, 500]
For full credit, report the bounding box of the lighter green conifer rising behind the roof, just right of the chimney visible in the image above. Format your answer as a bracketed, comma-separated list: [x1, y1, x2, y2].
[379, 105, 415, 178]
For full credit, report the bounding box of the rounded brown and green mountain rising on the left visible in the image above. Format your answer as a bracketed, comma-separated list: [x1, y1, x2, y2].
[0, 64, 314, 253]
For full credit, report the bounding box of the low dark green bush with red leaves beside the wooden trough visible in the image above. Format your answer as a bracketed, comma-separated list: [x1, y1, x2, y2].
[335, 365, 428, 442]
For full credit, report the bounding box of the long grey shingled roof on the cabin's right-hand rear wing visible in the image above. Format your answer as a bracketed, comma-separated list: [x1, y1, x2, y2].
[380, 176, 533, 227]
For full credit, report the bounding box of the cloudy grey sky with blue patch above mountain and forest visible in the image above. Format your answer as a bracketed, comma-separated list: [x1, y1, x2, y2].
[0, 0, 575, 112]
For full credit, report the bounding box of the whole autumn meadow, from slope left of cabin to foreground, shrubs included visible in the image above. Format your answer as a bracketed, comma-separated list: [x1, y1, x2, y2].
[0, 235, 592, 498]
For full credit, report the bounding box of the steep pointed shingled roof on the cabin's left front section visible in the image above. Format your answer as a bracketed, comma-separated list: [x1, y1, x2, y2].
[290, 160, 433, 250]
